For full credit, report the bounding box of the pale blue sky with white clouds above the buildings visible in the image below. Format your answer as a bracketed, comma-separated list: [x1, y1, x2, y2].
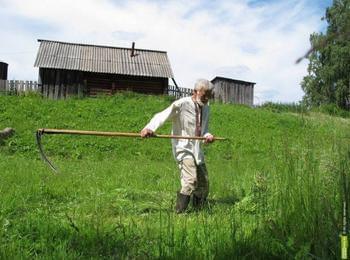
[0, 0, 332, 104]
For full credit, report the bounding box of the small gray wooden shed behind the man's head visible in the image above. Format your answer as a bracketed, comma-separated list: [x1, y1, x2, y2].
[211, 77, 255, 106]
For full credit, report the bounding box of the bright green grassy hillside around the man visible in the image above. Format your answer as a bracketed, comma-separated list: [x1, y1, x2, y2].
[0, 93, 350, 259]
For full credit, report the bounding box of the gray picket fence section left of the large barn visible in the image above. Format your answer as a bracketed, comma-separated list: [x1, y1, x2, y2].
[0, 80, 39, 94]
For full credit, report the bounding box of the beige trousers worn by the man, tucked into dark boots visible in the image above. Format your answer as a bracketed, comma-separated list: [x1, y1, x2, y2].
[179, 158, 209, 198]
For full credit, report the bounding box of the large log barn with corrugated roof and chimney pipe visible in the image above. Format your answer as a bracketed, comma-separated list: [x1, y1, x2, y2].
[34, 40, 173, 99]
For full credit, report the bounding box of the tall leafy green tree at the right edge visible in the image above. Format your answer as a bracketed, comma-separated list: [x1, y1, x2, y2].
[297, 0, 350, 109]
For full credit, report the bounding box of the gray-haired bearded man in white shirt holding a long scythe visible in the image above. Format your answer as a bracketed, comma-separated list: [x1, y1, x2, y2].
[141, 79, 214, 213]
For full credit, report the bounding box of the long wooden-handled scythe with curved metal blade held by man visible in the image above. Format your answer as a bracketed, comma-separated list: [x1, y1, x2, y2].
[36, 128, 226, 173]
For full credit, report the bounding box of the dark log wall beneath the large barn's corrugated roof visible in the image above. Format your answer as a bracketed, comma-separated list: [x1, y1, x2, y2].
[39, 68, 168, 99]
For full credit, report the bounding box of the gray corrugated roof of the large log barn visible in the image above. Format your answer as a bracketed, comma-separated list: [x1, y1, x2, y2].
[34, 40, 174, 78]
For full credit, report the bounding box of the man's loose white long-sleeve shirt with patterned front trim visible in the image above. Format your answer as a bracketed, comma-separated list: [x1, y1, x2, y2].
[145, 97, 210, 165]
